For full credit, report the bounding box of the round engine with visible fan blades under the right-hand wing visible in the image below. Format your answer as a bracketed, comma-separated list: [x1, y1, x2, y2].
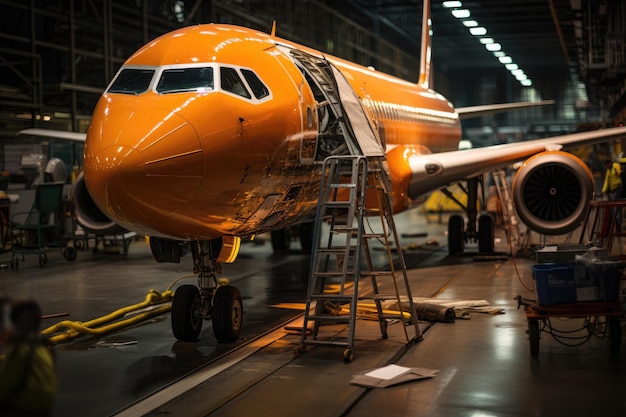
[512, 151, 594, 235]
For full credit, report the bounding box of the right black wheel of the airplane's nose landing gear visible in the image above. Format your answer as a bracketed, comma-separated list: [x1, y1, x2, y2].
[211, 285, 243, 342]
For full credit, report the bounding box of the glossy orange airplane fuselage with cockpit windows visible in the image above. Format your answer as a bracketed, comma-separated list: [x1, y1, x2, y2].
[84, 24, 461, 239]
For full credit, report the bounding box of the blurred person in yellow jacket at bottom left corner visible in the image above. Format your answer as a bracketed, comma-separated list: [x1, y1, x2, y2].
[0, 300, 58, 417]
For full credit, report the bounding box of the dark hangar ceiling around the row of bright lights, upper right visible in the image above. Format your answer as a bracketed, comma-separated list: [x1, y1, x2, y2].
[338, 0, 626, 123]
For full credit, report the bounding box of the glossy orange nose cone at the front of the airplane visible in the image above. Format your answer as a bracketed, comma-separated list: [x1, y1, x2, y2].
[84, 104, 203, 229]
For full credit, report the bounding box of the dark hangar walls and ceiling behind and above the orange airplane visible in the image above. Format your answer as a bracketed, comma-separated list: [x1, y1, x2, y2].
[0, 0, 626, 174]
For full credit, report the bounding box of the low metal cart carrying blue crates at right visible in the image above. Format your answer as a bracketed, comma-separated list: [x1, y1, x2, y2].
[515, 295, 624, 356]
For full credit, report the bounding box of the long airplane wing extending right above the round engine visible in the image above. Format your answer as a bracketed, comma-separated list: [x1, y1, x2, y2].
[408, 127, 626, 199]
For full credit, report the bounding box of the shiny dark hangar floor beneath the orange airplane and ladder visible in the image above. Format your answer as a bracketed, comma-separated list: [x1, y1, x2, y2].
[0, 189, 626, 417]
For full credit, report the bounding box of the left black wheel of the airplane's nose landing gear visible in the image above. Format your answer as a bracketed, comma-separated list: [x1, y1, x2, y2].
[172, 285, 202, 342]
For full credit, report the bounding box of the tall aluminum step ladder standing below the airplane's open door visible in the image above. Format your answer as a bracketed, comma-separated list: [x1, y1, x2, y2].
[296, 156, 421, 362]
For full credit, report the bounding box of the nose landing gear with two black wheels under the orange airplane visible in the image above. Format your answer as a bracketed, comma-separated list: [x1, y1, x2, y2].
[171, 237, 243, 342]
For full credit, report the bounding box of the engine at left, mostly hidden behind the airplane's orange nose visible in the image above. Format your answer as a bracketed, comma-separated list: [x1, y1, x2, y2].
[71, 173, 128, 235]
